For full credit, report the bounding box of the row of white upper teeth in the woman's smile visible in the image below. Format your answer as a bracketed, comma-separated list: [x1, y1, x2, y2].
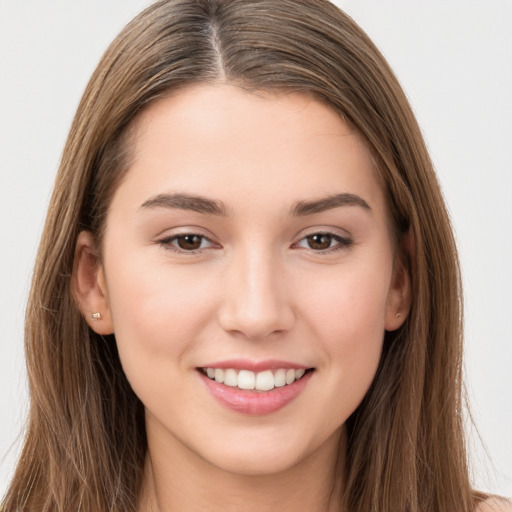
[205, 368, 306, 391]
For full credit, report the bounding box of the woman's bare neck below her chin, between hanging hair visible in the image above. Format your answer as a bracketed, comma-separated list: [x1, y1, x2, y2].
[139, 424, 345, 512]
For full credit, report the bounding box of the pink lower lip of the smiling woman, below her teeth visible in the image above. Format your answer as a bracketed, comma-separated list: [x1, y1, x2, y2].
[199, 371, 313, 415]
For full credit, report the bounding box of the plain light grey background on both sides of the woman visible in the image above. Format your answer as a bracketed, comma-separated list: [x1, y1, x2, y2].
[0, 0, 512, 496]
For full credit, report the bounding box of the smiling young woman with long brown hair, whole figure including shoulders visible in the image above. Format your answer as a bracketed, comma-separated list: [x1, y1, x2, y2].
[3, 0, 505, 512]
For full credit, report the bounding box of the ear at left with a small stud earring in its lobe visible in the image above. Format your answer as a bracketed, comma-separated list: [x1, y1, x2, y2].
[71, 231, 114, 334]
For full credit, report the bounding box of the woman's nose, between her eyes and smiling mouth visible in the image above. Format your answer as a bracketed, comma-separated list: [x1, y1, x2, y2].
[219, 250, 295, 340]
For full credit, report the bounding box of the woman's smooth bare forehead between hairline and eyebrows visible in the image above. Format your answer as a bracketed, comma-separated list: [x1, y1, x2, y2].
[114, 85, 383, 218]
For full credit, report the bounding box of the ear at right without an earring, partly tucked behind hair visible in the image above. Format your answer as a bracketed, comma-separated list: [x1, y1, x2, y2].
[385, 229, 414, 331]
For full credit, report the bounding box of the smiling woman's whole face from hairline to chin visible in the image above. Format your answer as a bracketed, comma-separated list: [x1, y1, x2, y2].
[79, 85, 404, 474]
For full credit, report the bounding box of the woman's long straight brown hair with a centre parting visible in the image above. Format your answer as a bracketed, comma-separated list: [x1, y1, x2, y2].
[3, 0, 480, 512]
